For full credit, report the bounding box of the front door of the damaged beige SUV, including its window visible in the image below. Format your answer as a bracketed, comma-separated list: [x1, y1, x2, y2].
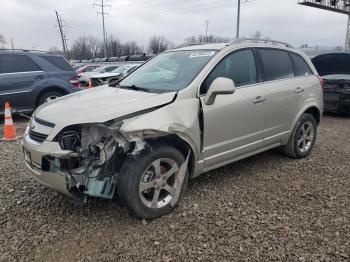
[200, 49, 266, 169]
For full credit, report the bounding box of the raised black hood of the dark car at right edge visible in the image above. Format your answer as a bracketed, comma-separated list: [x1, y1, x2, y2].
[312, 53, 350, 76]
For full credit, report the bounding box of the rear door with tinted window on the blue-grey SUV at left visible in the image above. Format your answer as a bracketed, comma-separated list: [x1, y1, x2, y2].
[0, 53, 44, 110]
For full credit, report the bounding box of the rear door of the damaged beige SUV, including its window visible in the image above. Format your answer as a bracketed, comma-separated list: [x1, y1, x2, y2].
[258, 48, 307, 145]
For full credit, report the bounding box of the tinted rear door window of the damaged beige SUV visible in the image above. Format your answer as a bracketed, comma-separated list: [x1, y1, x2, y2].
[259, 49, 294, 81]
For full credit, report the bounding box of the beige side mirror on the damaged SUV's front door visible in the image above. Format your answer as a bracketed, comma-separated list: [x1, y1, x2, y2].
[204, 77, 236, 106]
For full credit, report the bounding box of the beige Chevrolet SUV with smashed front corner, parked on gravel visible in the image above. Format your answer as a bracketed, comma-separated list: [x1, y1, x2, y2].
[23, 39, 323, 218]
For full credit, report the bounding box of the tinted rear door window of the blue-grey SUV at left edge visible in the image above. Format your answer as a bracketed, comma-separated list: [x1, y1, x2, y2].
[1, 54, 41, 73]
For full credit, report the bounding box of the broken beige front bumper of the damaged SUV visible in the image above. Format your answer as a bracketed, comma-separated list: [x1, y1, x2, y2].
[22, 132, 79, 199]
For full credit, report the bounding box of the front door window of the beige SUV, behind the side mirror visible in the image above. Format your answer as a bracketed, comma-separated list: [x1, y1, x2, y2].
[201, 50, 257, 94]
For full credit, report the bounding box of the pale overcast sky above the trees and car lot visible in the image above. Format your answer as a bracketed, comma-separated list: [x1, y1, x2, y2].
[0, 0, 347, 50]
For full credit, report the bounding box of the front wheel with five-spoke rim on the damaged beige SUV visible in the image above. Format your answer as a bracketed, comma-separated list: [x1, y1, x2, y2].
[117, 143, 189, 219]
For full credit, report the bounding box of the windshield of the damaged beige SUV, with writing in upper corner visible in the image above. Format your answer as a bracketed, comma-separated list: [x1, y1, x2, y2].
[119, 50, 217, 92]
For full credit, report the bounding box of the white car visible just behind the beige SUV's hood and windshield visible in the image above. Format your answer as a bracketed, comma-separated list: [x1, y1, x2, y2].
[89, 64, 141, 87]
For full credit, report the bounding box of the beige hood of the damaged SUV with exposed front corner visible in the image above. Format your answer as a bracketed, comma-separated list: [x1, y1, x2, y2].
[34, 85, 176, 134]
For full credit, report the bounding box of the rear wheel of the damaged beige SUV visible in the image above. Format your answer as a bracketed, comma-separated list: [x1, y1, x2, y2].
[283, 113, 317, 159]
